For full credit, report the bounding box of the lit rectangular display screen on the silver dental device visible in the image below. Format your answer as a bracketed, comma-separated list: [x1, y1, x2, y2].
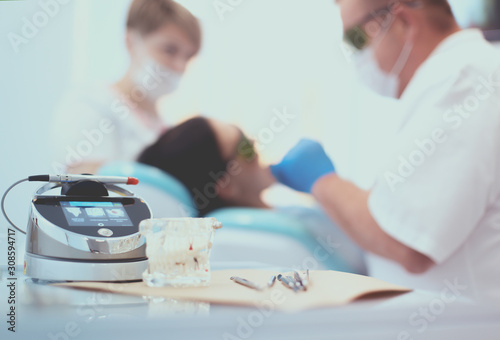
[61, 201, 133, 227]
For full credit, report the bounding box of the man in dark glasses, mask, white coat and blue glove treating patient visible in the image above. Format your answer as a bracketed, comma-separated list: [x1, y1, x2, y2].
[272, 0, 500, 300]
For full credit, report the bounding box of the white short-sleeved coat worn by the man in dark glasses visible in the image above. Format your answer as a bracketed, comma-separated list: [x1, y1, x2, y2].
[368, 30, 500, 299]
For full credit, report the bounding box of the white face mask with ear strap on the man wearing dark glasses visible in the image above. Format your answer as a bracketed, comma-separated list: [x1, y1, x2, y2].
[354, 40, 413, 98]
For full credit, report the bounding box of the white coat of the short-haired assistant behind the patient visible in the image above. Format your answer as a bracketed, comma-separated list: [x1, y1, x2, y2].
[51, 85, 166, 172]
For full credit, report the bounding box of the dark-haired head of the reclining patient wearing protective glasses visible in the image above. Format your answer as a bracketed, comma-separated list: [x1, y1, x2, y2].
[139, 117, 275, 216]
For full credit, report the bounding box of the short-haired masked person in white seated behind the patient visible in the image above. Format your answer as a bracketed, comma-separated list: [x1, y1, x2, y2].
[51, 0, 201, 173]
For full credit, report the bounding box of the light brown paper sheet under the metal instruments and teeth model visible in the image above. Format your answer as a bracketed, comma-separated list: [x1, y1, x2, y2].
[55, 269, 411, 311]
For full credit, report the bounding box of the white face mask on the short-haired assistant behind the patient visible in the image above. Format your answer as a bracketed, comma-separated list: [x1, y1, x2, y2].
[132, 57, 181, 99]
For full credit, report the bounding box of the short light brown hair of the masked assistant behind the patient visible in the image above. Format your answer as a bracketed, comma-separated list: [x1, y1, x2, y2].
[127, 0, 202, 52]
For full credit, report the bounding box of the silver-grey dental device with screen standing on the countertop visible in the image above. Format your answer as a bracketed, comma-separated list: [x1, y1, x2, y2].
[3, 176, 152, 282]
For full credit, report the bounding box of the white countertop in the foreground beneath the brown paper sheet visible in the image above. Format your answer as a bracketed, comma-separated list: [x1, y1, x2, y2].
[0, 263, 500, 340]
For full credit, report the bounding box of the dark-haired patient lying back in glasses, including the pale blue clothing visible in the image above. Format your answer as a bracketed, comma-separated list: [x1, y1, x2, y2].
[139, 117, 365, 273]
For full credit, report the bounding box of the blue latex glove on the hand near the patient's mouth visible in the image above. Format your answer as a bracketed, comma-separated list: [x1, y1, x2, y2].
[271, 139, 335, 193]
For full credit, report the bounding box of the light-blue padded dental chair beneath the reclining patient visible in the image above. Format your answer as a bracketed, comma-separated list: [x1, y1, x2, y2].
[99, 162, 359, 272]
